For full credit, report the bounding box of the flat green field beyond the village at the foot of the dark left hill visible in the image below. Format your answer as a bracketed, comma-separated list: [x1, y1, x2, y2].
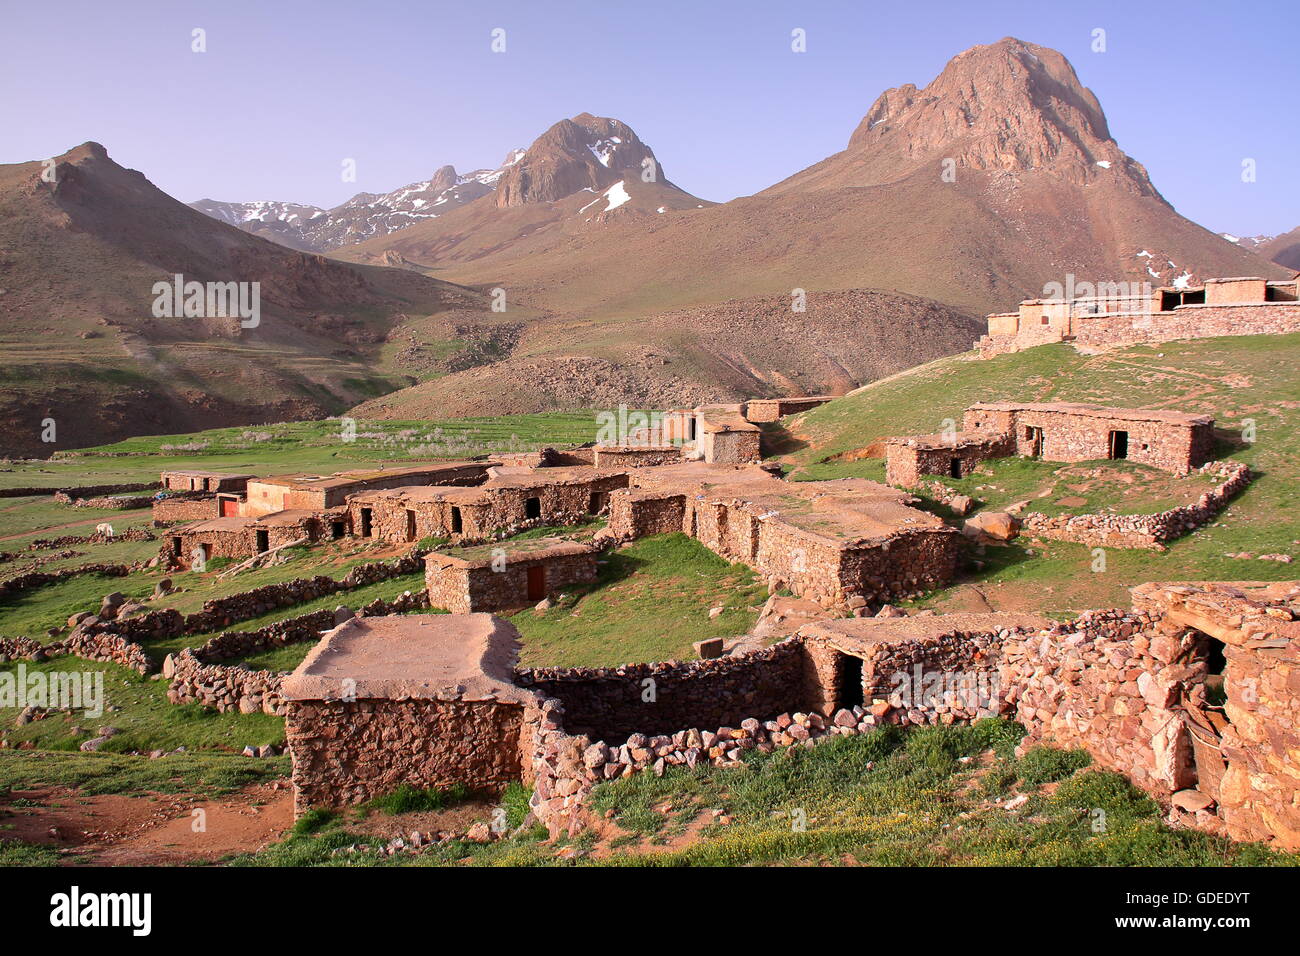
[0, 412, 618, 489]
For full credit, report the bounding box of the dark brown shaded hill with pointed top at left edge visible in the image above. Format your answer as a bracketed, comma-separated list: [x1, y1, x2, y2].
[0, 143, 517, 455]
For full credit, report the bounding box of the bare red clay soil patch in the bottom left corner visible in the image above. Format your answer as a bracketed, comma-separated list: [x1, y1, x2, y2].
[0, 782, 294, 866]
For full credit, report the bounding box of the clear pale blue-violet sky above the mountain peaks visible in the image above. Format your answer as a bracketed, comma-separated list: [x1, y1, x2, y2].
[0, 0, 1300, 235]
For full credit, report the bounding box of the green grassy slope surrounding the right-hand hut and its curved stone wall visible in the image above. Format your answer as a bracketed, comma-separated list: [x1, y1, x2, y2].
[785, 334, 1300, 611]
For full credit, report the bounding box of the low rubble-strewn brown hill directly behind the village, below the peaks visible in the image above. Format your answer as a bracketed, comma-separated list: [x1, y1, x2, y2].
[355, 290, 983, 419]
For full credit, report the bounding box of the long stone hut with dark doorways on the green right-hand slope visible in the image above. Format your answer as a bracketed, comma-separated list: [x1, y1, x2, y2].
[962, 402, 1214, 475]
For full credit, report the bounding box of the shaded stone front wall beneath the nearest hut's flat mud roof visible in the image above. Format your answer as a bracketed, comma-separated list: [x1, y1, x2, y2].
[285, 698, 524, 814]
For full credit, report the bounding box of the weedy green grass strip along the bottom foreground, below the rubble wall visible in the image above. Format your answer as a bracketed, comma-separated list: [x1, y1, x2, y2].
[226, 721, 1300, 866]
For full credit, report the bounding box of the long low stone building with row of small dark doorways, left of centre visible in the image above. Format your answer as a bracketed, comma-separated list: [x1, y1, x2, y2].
[347, 466, 628, 542]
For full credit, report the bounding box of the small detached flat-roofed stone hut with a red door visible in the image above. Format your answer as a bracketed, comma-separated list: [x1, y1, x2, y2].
[424, 537, 597, 614]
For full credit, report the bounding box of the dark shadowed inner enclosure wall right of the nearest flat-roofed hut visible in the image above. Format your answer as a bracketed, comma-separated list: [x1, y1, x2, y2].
[516, 641, 806, 743]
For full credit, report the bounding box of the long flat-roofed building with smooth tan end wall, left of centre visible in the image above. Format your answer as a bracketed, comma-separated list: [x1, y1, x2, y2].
[242, 460, 493, 518]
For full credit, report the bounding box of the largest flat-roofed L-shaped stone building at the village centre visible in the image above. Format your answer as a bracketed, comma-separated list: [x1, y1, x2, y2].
[607, 463, 958, 613]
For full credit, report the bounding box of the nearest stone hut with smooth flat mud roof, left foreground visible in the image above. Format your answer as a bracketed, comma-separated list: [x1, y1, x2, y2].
[281, 614, 536, 814]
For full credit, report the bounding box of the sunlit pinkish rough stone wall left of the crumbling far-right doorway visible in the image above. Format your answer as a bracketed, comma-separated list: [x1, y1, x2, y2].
[1000, 610, 1206, 797]
